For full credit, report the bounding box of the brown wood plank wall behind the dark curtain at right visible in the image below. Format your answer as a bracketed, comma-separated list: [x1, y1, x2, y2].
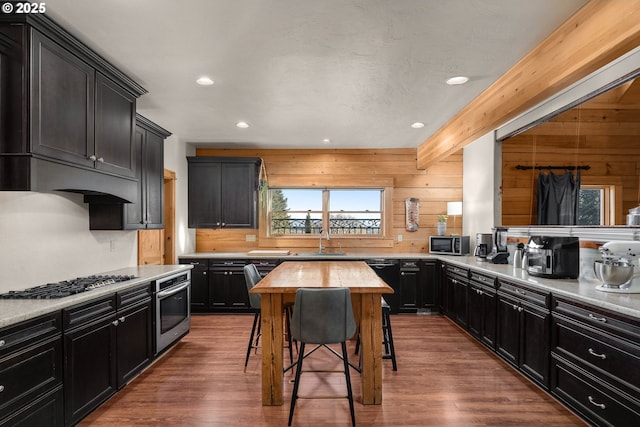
[502, 103, 640, 226]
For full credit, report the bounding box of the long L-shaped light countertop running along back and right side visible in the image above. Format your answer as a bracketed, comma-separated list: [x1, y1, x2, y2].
[180, 252, 640, 319]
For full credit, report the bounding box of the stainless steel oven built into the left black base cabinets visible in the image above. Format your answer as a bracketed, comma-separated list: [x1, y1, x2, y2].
[154, 271, 191, 354]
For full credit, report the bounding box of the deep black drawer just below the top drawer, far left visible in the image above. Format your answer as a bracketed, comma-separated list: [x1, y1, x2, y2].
[0, 336, 62, 414]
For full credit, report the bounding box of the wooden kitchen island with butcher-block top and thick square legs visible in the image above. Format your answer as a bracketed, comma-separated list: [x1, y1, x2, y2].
[251, 261, 393, 405]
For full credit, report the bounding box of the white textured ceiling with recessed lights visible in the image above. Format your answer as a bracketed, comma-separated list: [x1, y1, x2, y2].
[46, 0, 586, 148]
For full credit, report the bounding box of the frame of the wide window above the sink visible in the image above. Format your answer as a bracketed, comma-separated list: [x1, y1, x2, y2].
[265, 186, 388, 239]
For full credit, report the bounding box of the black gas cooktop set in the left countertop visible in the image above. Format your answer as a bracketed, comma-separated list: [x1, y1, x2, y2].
[0, 274, 136, 299]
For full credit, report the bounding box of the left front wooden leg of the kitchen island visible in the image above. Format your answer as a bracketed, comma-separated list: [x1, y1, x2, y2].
[261, 293, 283, 406]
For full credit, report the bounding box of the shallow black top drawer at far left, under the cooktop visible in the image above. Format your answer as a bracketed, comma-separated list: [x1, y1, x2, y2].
[0, 311, 62, 358]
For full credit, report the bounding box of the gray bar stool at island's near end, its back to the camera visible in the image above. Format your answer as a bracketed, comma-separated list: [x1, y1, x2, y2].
[288, 288, 356, 427]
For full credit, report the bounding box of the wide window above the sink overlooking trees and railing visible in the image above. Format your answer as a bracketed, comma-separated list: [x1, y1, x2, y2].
[269, 188, 384, 236]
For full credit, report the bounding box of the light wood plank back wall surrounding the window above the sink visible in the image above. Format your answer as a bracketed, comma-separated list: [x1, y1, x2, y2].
[196, 148, 462, 253]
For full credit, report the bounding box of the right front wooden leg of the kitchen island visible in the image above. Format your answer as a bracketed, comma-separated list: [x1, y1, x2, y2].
[360, 294, 382, 405]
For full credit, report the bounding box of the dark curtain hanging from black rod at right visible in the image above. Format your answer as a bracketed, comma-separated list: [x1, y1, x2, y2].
[538, 170, 580, 225]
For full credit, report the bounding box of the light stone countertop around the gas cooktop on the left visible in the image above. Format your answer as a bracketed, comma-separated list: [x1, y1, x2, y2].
[0, 265, 193, 328]
